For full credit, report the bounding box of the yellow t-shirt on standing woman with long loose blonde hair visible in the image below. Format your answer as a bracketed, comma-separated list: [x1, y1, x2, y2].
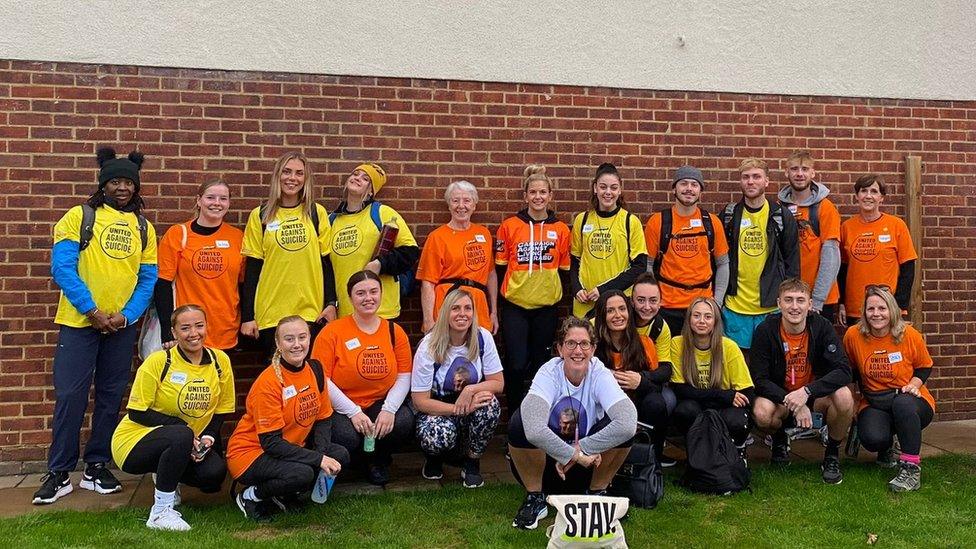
[241, 204, 332, 330]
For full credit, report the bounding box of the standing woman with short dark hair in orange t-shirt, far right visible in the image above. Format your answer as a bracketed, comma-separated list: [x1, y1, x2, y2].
[837, 174, 918, 326]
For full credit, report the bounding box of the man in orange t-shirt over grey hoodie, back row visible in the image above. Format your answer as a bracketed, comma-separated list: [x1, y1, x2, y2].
[779, 151, 840, 322]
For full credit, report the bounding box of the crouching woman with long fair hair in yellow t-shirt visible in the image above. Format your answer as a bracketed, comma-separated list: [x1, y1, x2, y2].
[671, 297, 755, 458]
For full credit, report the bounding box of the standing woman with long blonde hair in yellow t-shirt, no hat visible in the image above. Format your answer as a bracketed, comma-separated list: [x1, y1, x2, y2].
[241, 152, 336, 358]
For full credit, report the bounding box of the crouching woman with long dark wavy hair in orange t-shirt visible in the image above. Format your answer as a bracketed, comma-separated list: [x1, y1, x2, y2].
[593, 290, 675, 463]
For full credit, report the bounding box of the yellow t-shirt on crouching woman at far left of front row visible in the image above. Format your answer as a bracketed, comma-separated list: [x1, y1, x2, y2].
[112, 348, 236, 466]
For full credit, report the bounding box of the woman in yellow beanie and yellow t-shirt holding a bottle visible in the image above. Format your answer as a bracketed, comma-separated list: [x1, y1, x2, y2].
[329, 162, 420, 318]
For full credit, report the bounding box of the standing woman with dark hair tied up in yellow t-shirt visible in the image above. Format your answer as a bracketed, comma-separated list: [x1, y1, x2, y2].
[569, 162, 647, 318]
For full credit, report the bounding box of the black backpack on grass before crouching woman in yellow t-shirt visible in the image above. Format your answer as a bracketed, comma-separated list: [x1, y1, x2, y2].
[681, 410, 752, 495]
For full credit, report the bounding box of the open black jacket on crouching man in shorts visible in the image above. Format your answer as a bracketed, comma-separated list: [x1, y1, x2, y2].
[749, 313, 851, 404]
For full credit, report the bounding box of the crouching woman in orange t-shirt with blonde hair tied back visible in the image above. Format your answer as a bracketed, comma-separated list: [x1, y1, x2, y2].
[227, 316, 349, 522]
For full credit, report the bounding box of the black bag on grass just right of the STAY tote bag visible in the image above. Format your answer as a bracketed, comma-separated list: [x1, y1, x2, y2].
[609, 426, 664, 509]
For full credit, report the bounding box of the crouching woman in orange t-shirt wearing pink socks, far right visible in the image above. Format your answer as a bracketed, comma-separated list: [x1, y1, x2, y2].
[844, 286, 935, 492]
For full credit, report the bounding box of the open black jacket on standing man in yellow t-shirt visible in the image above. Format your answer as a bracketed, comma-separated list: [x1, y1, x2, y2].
[720, 200, 800, 307]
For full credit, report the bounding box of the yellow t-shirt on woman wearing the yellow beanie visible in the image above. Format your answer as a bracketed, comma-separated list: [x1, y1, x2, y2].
[329, 204, 417, 318]
